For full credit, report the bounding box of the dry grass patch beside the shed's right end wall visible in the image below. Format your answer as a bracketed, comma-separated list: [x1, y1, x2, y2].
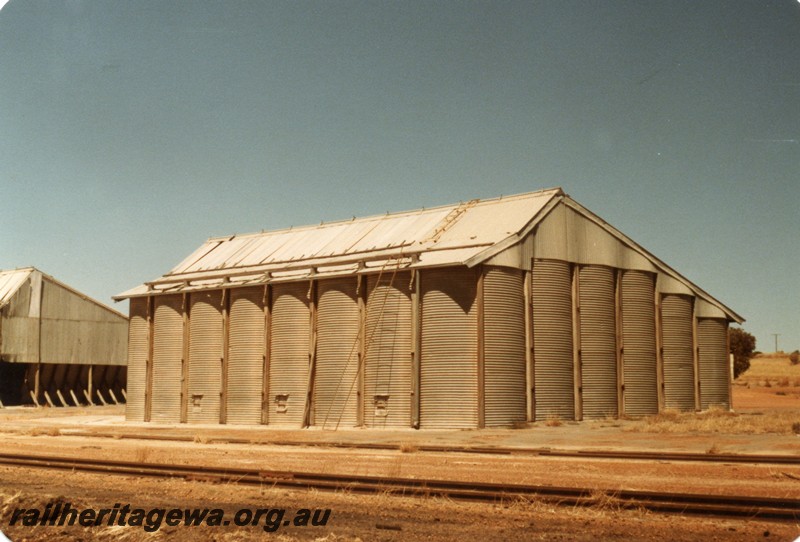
[623, 408, 800, 438]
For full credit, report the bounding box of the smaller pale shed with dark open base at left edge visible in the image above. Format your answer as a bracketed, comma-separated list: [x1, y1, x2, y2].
[0, 267, 128, 406]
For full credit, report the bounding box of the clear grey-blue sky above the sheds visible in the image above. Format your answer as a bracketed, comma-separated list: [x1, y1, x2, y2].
[0, 0, 800, 351]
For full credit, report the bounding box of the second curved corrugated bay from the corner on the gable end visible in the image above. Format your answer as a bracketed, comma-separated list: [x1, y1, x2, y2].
[531, 260, 575, 420]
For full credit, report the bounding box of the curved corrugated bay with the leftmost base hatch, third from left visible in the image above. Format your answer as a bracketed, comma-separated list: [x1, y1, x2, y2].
[186, 290, 224, 423]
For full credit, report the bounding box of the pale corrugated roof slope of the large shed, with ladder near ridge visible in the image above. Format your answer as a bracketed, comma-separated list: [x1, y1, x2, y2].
[114, 188, 564, 299]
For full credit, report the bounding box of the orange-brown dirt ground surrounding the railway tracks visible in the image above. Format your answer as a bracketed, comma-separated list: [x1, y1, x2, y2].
[0, 354, 800, 542]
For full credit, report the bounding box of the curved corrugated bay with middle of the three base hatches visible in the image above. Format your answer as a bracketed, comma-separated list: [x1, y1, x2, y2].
[267, 282, 311, 427]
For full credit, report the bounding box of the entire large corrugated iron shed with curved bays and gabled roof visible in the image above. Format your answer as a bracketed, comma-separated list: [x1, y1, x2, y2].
[115, 189, 740, 428]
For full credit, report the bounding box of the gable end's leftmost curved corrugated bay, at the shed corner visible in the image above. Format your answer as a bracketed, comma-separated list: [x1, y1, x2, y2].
[483, 267, 527, 427]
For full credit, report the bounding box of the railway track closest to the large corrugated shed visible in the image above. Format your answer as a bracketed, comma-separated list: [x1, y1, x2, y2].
[65, 431, 800, 465]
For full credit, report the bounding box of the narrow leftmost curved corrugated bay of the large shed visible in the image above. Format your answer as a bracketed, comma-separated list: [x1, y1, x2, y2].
[126, 297, 149, 422]
